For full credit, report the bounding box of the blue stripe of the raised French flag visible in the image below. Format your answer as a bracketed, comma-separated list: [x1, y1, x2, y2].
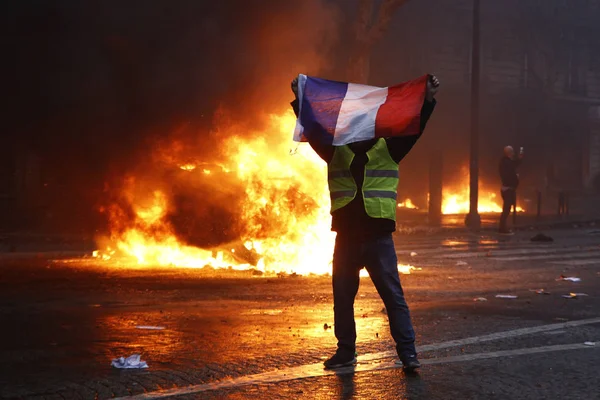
[300, 77, 348, 145]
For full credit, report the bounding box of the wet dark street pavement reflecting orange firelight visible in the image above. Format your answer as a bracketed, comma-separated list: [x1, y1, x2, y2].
[0, 229, 600, 399]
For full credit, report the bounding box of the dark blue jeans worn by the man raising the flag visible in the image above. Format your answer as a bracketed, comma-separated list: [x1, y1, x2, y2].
[333, 233, 416, 358]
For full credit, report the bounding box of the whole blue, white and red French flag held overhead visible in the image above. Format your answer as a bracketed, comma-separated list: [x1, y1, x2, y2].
[294, 74, 429, 146]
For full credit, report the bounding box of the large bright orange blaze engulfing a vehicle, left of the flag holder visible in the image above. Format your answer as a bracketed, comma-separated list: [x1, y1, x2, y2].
[95, 112, 335, 274]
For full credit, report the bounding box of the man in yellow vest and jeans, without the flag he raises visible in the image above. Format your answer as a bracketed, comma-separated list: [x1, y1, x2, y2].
[292, 75, 440, 370]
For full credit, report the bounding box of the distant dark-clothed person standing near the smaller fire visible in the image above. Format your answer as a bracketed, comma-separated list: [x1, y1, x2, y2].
[499, 146, 523, 235]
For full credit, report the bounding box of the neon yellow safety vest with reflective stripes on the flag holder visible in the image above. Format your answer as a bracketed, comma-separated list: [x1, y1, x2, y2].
[328, 139, 398, 221]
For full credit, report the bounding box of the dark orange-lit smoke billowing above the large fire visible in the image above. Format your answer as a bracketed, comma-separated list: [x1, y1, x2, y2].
[1, 0, 339, 234]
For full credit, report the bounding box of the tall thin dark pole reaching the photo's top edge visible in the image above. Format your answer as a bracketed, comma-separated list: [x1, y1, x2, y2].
[465, 0, 481, 229]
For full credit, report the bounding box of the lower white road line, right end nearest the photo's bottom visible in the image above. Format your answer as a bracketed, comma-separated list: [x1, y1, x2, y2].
[115, 343, 599, 400]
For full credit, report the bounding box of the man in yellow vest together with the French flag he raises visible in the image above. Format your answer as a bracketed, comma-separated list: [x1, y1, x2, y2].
[292, 75, 439, 370]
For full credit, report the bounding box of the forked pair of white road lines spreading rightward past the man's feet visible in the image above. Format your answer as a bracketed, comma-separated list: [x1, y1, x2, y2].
[115, 318, 600, 400]
